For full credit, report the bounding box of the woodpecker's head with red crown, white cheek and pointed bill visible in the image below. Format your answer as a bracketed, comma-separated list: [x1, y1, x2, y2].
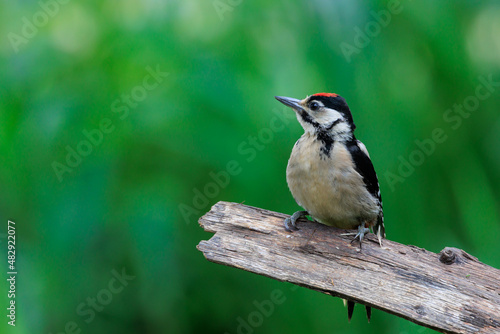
[276, 93, 356, 140]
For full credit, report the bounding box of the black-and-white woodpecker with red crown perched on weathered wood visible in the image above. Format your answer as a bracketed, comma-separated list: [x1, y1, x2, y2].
[275, 93, 386, 321]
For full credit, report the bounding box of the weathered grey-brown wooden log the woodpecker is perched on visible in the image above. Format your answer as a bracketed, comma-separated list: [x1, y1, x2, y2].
[198, 202, 500, 333]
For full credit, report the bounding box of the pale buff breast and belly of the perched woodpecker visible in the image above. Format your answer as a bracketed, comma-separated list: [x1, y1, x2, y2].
[287, 134, 380, 229]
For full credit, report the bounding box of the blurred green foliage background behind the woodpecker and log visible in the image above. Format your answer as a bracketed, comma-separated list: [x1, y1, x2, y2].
[0, 0, 500, 334]
